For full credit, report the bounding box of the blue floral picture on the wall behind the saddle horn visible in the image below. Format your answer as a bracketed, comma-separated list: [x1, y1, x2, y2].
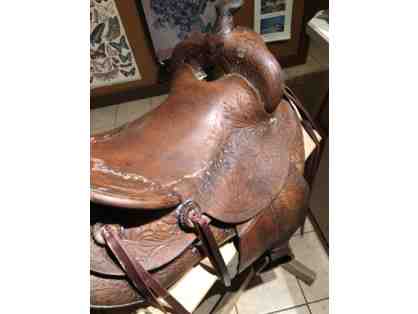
[142, 0, 217, 62]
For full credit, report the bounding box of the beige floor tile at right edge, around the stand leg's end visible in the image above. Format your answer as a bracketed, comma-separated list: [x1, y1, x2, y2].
[290, 232, 329, 302]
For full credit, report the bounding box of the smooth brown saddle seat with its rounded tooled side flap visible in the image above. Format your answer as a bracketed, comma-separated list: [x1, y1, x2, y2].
[91, 64, 291, 223]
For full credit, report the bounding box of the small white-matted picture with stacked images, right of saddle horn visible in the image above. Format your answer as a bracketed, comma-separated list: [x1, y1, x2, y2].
[254, 0, 293, 42]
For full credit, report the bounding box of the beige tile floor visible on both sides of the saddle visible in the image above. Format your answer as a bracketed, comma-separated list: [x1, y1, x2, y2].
[90, 96, 329, 314]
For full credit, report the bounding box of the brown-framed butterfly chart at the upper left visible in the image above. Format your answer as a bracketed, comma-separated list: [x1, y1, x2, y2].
[90, 0, 168, 108]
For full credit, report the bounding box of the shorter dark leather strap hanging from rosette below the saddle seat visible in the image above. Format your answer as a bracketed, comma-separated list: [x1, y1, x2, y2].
[190, 211, 231, 287]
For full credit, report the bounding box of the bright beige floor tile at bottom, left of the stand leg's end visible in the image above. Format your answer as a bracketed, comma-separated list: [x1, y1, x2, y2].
[237, 267, 305, 314]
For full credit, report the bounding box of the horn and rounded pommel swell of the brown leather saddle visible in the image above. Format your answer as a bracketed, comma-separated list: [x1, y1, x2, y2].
[172, 0, 284, 113]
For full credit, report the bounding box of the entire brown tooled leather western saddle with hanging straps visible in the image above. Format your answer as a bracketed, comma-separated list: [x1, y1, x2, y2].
[90, 1, 318, 314]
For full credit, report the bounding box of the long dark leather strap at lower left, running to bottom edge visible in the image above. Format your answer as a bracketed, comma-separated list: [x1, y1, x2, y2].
[102, 225, 190, 314]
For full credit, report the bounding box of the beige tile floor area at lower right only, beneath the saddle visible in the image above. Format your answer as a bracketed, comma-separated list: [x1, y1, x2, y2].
[235, 226, 328, 314]
